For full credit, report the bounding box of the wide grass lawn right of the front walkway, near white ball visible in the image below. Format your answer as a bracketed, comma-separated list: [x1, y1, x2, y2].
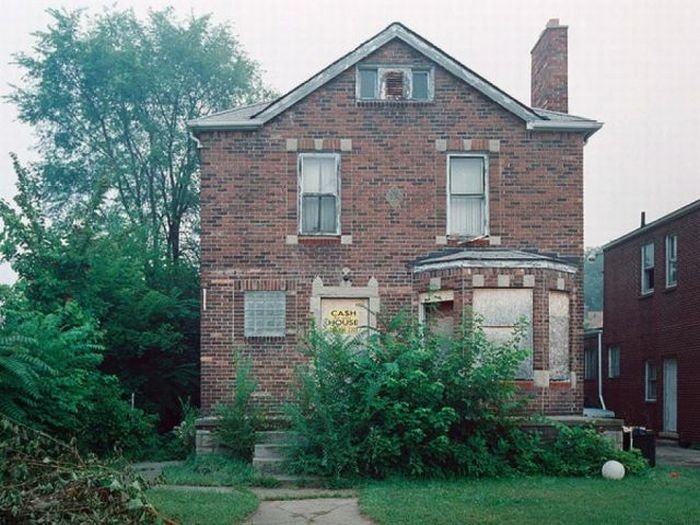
[360, 468, 700, 525]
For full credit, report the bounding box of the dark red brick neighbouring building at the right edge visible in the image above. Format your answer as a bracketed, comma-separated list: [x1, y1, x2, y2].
[602, 200, 700, 443]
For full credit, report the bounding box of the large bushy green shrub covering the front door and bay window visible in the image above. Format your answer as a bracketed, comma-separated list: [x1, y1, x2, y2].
[289, 314, 524, 478]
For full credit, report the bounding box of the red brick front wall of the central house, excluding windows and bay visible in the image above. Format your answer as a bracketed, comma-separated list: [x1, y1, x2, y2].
[199, 41, 583, 416]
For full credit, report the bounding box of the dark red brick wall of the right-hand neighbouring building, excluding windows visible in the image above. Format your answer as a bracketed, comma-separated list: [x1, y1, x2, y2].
[603, 205, 700, 442]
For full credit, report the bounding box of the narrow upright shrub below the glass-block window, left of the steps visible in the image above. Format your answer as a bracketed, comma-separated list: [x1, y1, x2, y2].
[214, 358, 260, 461]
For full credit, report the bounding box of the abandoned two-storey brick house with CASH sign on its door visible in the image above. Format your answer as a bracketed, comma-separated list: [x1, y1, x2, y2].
[190, 20, 601, 414]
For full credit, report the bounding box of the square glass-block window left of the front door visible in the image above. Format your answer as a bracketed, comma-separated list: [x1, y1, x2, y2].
[243, 292, 287, 337]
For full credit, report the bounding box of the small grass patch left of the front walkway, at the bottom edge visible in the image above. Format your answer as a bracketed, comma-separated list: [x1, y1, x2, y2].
[148, 487, 258, 525]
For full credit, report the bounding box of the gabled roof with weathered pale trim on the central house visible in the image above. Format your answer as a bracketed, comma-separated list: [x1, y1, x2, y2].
[188, 22, 602, 138]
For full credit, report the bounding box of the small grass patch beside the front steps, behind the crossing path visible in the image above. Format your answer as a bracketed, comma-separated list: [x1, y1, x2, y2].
[163, 454, 275, 487]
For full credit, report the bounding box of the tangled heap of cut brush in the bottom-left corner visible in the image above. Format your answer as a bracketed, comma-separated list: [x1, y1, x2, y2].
[0, 417, 174, 525]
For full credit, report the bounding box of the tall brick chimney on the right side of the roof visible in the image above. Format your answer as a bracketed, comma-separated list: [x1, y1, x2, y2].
[530, 18, 569, 113]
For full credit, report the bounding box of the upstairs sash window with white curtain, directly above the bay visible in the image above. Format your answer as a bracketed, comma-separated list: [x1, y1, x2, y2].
[447, 155, 488, 237]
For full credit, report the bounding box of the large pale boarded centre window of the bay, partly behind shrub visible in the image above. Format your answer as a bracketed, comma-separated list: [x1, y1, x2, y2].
[472, 288, 533, 379]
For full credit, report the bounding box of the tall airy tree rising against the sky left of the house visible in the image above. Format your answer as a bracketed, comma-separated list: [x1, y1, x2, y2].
[9, 9, 270, 261]
